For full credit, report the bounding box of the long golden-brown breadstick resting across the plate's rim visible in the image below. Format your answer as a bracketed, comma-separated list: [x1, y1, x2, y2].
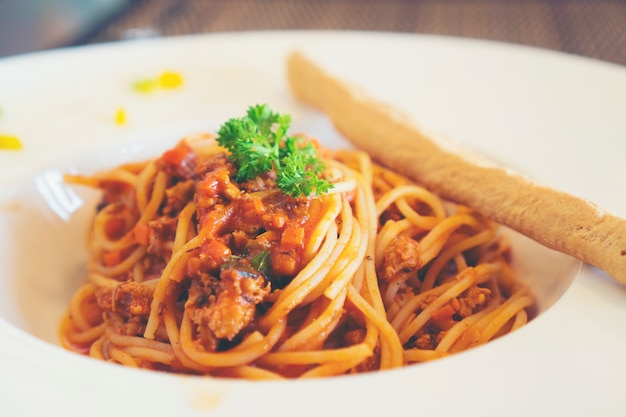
[287, 52, 626, 284]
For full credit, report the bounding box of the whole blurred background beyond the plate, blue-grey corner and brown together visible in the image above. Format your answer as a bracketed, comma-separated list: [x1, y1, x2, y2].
[0, 0, 626, 65]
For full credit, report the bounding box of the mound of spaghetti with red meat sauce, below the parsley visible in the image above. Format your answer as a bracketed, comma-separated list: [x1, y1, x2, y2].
[60, 123, 534, 379]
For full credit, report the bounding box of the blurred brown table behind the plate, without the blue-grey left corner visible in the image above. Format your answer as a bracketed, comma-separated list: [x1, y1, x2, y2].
[77, 0, 626, 65]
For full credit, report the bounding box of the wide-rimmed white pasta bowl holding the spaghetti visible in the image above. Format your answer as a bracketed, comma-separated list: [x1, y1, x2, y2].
[0, 32, 626, 416]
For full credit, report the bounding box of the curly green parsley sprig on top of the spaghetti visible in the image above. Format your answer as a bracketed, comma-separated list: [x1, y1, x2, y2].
[217, 104, 333, 197]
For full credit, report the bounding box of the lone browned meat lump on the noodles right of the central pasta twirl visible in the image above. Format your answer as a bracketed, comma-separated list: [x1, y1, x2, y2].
[382, 235, 421, 282]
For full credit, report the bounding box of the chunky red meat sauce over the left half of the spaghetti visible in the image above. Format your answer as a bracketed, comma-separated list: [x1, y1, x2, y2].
[96, 142, 325, 351]
